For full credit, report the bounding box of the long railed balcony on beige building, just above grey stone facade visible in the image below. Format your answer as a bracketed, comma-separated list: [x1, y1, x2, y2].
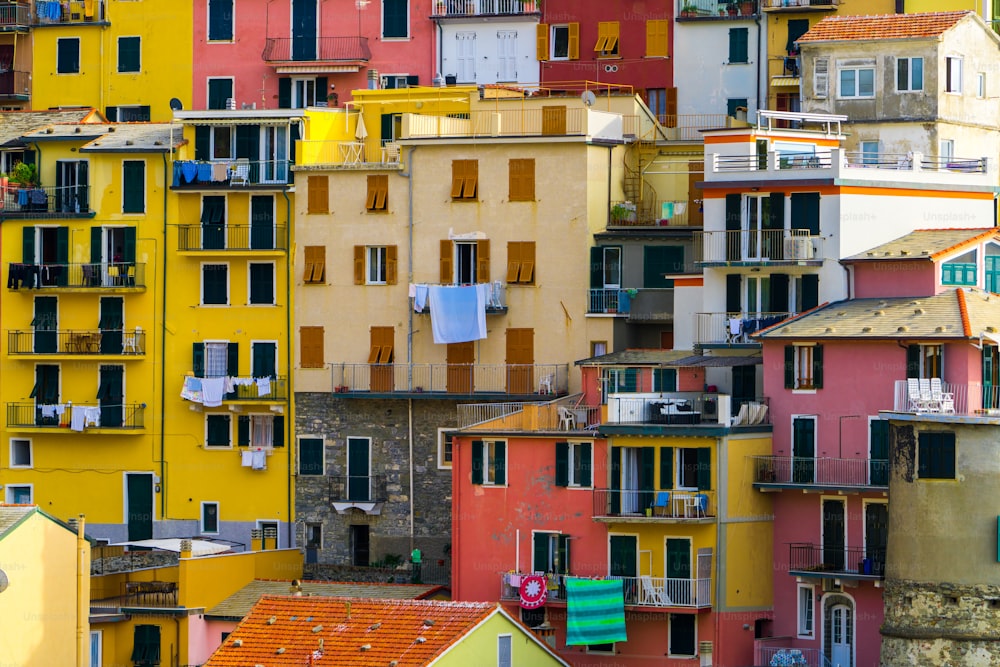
[331, 363, 569, 399]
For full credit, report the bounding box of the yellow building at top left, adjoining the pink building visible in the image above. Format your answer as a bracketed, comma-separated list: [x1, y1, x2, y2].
[30, 0, 194, 122]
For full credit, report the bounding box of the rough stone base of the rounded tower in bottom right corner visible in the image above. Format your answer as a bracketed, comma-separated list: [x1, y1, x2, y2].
[881, 580, 1000, 667]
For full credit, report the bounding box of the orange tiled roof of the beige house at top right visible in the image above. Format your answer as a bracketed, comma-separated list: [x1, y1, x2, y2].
[798, 11, 973, 44]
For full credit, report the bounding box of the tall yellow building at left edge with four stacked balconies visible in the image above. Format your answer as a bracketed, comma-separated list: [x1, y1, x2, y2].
[0, 122, 180, 541]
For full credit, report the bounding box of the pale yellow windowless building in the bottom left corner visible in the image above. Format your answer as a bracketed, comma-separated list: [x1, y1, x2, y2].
[0, 504, 90, 667]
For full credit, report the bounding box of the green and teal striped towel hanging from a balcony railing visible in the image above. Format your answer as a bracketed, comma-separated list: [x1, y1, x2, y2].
[565, 577, 627, 646]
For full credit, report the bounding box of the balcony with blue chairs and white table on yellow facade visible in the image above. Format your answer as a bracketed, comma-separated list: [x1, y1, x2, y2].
[593, 489, 717, 523]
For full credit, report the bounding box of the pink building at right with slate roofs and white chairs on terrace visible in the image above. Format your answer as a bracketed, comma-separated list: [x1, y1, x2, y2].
[753, 229, 1000, 667]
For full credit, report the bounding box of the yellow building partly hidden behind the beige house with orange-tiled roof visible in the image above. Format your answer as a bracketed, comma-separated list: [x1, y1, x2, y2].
[761, 0, 896, 111]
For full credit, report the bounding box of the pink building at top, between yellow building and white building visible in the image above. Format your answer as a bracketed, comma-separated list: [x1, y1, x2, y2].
[192, 0, 435, 109]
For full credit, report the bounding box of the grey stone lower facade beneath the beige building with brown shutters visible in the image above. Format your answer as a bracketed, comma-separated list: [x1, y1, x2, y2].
[295, 392, 457, 567]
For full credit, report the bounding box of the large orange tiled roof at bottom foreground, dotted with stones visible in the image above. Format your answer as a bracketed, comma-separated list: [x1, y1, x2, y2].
[205, 595, 499, 667]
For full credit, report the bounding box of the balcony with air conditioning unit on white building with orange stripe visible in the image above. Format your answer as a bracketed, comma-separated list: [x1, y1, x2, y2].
[695, 229, 823, 266]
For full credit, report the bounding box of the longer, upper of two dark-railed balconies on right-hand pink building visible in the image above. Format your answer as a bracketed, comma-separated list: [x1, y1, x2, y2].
[748, 456, 889, 491]
